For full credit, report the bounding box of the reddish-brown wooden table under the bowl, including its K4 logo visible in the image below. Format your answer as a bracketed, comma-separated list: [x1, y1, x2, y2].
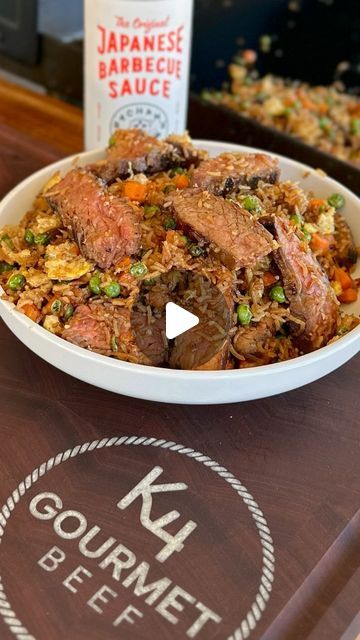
[0, 83, 360, 640]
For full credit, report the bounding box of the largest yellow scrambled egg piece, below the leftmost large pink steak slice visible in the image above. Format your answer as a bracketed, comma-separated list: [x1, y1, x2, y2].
[44, 240, 92, 280]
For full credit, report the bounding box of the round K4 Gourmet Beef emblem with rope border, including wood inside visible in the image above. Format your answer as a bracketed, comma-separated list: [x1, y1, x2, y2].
[0, 436, 275, 640]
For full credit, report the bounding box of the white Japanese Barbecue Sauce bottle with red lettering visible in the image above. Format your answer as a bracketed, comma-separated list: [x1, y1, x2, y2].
[85, 0, 193, 149]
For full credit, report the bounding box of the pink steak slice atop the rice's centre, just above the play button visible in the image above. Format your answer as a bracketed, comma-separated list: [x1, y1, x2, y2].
[165, 189, 274, 269]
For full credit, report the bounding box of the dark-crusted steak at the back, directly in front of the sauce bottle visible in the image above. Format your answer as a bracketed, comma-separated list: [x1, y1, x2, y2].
[89, 129, 205, 182]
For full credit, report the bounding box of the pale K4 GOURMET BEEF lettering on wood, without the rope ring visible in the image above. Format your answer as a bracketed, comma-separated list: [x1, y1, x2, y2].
[29, 466, 218, 638]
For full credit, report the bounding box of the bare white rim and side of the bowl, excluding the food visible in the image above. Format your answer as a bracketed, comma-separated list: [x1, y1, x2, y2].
[0, 140, 360, 404]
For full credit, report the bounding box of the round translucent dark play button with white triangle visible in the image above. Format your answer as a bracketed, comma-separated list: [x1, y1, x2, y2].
[131, 268, 232, 369]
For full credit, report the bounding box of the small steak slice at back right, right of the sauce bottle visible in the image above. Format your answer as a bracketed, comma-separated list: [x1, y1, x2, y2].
[191, 153, 280, 196]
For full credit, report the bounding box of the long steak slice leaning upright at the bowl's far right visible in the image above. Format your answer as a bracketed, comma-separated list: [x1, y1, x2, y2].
[274, 217, 339, 351]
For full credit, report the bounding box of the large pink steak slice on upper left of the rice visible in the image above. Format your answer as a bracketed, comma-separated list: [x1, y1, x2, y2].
[46, 169, 140, 269]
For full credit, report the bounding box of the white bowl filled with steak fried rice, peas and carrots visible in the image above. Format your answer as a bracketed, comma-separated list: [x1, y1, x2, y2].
[0, 130, 360, 404]
